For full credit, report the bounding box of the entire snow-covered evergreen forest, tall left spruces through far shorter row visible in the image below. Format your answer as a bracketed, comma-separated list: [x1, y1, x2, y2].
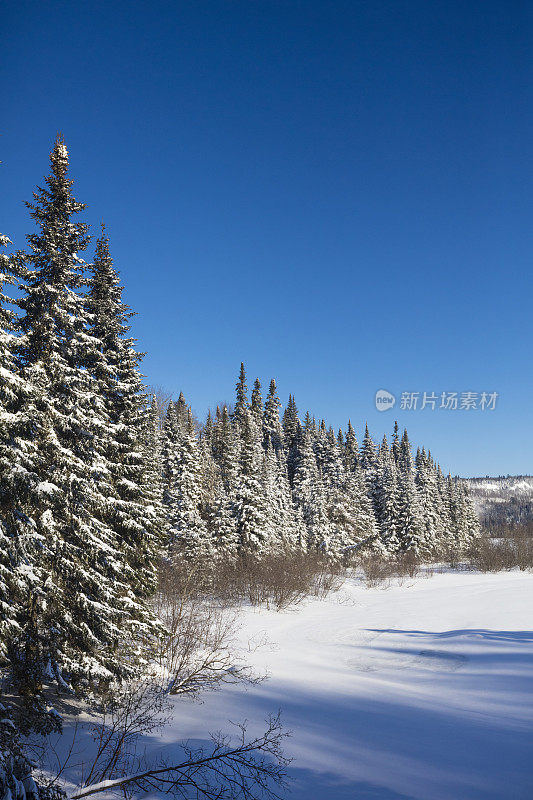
[0, 137, 477, 800]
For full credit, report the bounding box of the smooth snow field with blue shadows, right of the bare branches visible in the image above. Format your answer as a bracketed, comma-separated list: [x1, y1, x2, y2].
[52, 572, 533, 800]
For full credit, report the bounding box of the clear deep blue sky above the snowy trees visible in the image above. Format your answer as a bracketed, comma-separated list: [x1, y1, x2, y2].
[0, 0, 533, 475]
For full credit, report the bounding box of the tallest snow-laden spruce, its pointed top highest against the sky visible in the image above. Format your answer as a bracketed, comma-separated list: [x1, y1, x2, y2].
[12, 136, 149, 693]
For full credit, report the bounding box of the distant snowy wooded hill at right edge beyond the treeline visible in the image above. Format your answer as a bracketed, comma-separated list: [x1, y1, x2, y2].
[466, 475, 533, 529]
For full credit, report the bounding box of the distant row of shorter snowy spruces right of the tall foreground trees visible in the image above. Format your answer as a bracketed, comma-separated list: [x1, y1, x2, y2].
[156, 365, 479, 560]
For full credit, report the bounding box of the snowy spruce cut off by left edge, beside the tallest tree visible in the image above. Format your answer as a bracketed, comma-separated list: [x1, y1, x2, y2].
[0, 236, 65, 800]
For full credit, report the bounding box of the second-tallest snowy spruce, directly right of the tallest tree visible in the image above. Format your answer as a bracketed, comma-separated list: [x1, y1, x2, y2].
[86, 225, 161, 596]
